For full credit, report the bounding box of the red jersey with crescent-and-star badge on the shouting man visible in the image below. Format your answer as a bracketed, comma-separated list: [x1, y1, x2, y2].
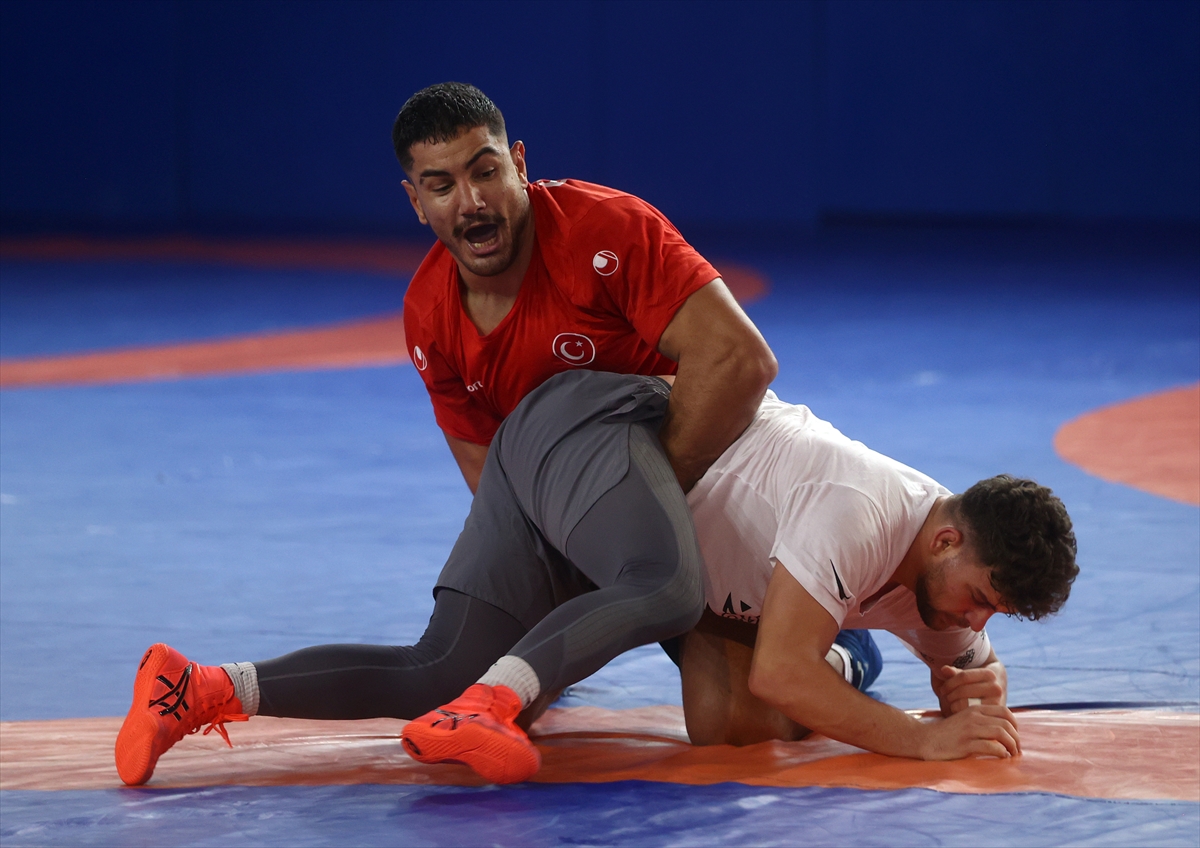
[404, 180, 719, 445]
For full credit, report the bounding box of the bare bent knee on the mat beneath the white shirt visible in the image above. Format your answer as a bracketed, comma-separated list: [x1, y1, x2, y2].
[679, 609, 809, 745]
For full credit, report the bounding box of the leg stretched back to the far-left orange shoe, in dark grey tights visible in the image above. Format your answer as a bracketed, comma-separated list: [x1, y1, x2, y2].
[116, 441, 553, 784]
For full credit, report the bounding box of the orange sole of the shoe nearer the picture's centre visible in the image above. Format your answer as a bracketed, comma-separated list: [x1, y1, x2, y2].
[400, 723, 541, 783]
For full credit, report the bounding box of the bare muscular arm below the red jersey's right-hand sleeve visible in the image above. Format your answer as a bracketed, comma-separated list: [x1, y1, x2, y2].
[659, 279, 779, 492]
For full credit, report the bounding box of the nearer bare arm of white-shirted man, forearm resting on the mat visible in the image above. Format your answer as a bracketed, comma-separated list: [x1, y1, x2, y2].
[750, 565, 1020, 759]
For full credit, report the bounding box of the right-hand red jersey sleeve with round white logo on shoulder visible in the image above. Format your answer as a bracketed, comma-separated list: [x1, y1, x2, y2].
[571, 194, 721, 348]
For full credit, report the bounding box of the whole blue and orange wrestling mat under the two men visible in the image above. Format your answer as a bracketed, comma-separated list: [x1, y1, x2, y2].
[0, 234, 1200, 846]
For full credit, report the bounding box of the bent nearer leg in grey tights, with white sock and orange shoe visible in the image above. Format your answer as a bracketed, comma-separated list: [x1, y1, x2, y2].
[402, 425, 703, 782]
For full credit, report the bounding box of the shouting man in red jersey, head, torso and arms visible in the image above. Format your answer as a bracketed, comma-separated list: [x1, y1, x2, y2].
[392, 83, 778, 492]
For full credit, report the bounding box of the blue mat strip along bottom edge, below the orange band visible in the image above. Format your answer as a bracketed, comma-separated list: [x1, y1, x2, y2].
[0, 781, 1200, 848]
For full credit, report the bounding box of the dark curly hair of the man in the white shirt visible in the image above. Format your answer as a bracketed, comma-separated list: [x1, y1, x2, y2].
[953, 474, 1079, 621]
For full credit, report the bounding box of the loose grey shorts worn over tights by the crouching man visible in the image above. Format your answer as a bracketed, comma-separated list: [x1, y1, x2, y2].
[434, 371, 702, 629]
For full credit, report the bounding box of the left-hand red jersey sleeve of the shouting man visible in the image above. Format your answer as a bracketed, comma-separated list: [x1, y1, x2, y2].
[404, 286, 500, 445]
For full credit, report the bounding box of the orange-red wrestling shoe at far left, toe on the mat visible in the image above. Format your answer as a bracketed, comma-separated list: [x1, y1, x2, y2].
[116, 643, 250, 786]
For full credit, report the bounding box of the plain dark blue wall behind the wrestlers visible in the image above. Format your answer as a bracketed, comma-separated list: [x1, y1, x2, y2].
[0, 0, 1200, 235]
